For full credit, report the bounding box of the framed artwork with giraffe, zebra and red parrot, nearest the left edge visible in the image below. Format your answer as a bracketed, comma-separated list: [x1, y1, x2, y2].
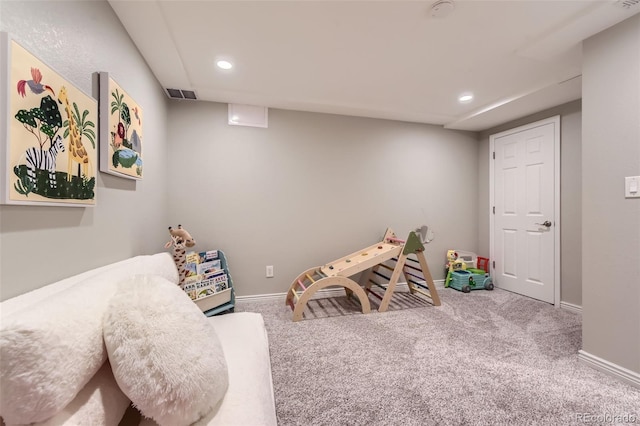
[0, 32, 98, 207]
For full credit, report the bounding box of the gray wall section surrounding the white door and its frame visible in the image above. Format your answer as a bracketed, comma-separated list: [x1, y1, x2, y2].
[478, 101, 582, 306]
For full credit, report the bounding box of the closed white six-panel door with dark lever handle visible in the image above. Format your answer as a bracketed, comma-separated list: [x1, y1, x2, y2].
[490, 117, 560, 304]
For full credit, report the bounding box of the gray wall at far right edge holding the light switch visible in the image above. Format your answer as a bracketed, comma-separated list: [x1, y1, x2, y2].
[582, 15, 640, 373]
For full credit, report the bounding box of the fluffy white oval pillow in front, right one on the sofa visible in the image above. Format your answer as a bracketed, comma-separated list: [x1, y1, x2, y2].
[103, 275, 229, 426]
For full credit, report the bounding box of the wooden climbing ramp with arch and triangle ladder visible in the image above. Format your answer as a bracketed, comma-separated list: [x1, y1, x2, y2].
[285, 229, 440, 321]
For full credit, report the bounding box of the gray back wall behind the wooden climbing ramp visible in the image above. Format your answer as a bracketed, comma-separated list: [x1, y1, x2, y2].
[169, 102, 478, 295]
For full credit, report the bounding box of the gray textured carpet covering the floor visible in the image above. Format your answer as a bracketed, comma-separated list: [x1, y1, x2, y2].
[236, 289, 640, 426]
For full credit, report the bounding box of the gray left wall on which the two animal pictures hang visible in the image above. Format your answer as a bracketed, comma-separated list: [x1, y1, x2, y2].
[0, 0, 170, 300]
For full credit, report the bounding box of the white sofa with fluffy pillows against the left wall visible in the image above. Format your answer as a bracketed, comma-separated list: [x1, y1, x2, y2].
[0, 253, 276, 426]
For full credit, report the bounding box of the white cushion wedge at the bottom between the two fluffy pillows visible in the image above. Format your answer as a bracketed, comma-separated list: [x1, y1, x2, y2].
[32, 361, 130, 426]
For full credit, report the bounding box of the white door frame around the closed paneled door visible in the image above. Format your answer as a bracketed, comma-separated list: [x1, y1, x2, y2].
[489, 115, 561, 308]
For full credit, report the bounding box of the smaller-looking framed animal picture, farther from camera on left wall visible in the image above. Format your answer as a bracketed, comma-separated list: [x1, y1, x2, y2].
[100, 72, 144, 180]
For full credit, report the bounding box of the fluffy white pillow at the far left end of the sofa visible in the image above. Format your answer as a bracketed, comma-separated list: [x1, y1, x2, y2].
[0, 276, 122, 424]
